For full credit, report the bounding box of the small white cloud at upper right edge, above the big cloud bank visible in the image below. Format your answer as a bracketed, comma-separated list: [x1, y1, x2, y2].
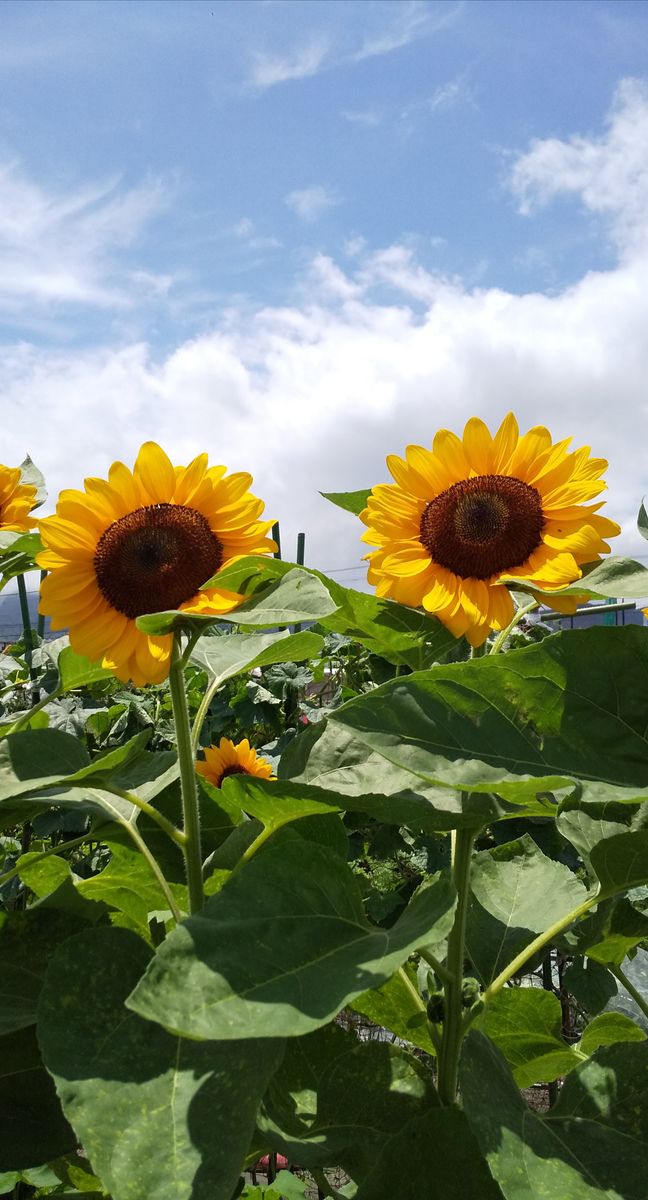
[511, 79, 648, 253]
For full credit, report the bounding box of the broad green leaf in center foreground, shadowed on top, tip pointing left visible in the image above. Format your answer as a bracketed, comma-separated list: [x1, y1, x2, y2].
[128, 829, 455, 1038]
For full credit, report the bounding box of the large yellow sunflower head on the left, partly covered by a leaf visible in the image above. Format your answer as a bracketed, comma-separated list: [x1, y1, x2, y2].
[37, 442, 275, 686]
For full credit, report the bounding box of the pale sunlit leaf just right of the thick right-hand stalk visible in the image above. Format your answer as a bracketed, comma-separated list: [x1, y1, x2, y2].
[466, 834, 588, 983]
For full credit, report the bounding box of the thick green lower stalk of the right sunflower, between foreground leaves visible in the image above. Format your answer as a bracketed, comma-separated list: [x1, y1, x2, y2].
[437, 829, 475, 1105]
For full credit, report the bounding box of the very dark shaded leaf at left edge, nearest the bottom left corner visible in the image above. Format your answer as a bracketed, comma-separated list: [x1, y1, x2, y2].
[0, 1027, 77, 1171]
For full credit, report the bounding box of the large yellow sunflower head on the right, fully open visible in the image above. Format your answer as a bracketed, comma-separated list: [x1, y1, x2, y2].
[360, 413, 620, 646]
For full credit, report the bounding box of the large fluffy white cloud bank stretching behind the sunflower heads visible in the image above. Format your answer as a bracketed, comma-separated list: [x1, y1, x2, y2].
[0, 75, 648, 583]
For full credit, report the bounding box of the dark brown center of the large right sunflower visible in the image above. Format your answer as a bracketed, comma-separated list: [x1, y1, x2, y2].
[419, 475, 545, 580]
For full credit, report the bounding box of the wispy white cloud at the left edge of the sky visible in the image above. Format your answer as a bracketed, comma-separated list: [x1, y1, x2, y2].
[0, 162, 168, 320]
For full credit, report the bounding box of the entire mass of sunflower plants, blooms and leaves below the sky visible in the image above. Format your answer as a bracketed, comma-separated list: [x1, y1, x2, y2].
[0, 432, 648, 1200]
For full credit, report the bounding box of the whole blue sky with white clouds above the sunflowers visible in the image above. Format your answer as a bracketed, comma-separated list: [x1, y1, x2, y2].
[0, 0, 648, 584]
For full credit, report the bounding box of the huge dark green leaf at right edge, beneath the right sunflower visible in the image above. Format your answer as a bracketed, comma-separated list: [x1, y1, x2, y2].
[330, 626, 648, 803]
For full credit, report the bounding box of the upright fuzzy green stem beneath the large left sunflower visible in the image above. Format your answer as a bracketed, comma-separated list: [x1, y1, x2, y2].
[169, 634, 204, 913]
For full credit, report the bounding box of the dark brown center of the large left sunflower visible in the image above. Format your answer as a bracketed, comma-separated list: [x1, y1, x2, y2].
[95, 504, 223, 618]
